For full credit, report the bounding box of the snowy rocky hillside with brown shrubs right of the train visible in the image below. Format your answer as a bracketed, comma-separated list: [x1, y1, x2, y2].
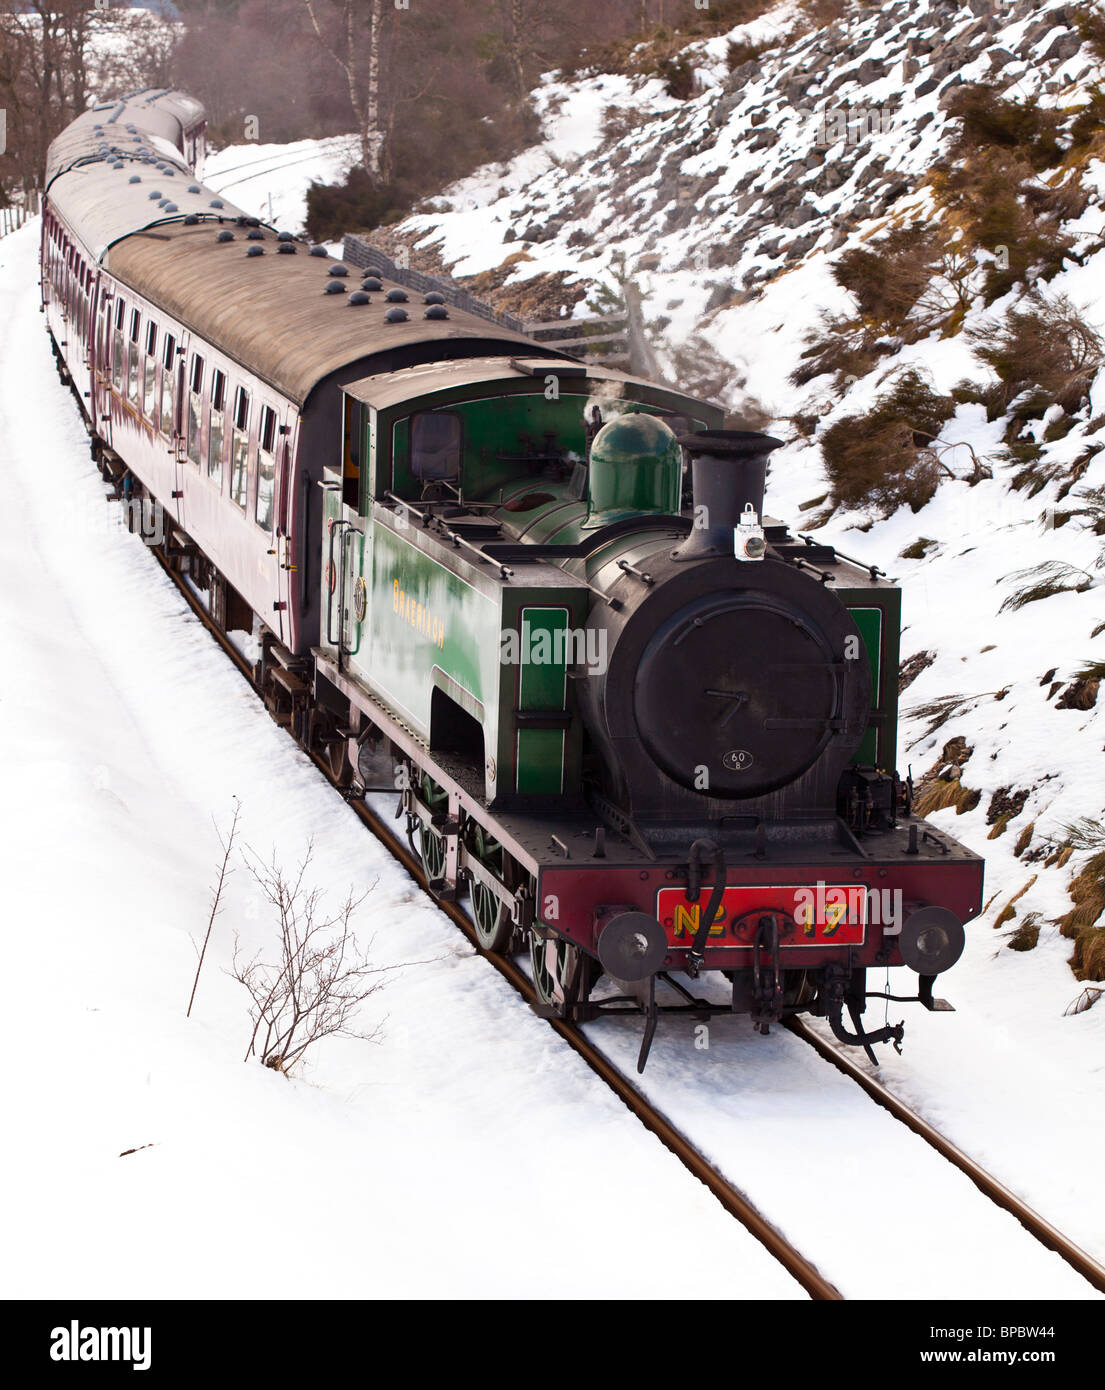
[391, 0, 1105, 1006]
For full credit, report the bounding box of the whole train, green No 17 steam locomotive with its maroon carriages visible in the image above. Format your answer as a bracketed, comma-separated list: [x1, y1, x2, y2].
[42, 90, 983, 1068]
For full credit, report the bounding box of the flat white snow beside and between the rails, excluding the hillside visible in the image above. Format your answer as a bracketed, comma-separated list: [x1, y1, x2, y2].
[0, 211, 1105, 1300]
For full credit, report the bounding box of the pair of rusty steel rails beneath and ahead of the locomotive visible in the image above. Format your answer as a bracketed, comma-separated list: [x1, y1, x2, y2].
[118, 478, 1105, 1301]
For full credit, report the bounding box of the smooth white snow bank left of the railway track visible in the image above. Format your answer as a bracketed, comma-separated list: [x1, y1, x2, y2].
[0, 222, 802, 1298]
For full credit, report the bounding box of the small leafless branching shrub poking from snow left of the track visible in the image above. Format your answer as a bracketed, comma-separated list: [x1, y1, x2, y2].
[229, 842, 386, 1072]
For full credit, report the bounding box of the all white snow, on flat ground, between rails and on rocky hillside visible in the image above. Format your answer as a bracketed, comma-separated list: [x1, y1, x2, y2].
[0, 0, 1105, 1300]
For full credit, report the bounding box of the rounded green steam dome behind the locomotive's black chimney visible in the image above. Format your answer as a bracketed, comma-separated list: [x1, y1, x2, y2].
[584, 410, 682, 530]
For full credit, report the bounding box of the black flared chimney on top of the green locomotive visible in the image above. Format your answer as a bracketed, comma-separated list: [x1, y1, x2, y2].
[673, 430, 783, 560]
